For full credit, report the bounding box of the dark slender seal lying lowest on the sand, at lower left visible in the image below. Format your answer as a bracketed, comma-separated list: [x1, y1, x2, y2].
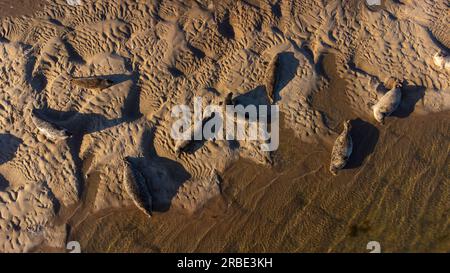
[124, 158, 152, 217]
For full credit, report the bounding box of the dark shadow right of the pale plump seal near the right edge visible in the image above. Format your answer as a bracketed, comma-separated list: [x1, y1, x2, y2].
[392, 82, 426, 118]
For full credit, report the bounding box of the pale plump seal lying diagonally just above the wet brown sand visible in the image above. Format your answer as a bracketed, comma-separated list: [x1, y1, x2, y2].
[373, 82, 402, 124]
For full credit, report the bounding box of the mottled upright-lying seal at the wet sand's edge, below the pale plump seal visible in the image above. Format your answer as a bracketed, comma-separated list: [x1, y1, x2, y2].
[330, 120, 353, 175]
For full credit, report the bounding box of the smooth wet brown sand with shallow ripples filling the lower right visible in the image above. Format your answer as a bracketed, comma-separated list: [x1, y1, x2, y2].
[70, 108, 450, 252]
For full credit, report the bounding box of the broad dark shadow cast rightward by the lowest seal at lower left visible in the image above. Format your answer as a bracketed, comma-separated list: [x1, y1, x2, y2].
[129, 130, 191, 212]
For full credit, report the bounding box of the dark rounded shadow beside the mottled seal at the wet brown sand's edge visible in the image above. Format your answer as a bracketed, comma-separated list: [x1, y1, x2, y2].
[344, 118, 380, 169]
